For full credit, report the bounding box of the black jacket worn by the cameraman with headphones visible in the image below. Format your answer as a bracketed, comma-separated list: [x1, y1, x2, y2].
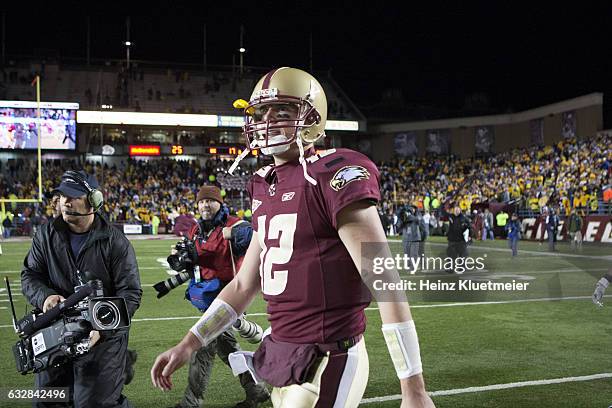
[21, 214, 142, 317]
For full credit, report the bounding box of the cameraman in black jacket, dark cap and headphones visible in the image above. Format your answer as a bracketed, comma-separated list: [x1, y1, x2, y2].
[21, 171, 142, 407]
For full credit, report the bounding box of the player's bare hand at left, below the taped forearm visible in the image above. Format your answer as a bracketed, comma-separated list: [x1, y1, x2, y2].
[151, 333, 201, 391]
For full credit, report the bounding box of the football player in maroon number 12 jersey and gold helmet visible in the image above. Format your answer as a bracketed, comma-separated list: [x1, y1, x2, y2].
[151, 68, 434, 408]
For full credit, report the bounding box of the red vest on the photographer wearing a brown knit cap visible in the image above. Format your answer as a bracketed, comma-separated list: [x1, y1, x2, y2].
[187, 215, 243, 283]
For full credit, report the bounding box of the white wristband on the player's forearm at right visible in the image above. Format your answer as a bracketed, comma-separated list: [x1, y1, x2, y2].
[382, 320, 423, 380]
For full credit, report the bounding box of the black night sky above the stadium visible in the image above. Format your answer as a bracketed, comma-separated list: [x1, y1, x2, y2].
[5, 1, 612, 121]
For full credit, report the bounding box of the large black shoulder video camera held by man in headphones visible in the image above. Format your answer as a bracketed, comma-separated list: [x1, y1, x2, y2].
[7, 280, 130, 374]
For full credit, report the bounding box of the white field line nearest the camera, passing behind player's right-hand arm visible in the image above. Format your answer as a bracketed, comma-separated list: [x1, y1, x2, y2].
[361, 373, 612, 404]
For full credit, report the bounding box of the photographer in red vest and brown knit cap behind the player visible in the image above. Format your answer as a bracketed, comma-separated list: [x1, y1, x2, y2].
[177, 186, 269, 408]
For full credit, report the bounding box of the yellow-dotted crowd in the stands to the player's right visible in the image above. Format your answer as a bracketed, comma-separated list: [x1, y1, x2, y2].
[379, 134, 612, 215]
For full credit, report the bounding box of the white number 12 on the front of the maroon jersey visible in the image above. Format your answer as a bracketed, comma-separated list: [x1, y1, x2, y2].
[257, 214, 297, 295]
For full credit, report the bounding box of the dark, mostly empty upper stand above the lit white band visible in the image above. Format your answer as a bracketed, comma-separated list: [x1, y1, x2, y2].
[0, 59, 363, 120]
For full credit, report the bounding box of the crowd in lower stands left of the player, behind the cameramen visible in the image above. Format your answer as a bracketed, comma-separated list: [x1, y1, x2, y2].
[0, 159, 254, 235]
